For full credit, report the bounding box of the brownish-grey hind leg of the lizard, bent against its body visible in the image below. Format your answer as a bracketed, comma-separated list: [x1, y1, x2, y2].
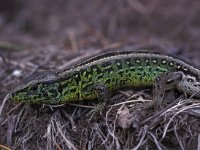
[153, 71, 184, 107]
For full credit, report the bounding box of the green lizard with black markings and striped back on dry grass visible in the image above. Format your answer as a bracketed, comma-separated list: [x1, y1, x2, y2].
[11, 51, 200, 104]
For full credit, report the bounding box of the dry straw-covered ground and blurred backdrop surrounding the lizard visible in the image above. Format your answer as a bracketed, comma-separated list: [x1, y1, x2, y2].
[0, 0, 200, 150]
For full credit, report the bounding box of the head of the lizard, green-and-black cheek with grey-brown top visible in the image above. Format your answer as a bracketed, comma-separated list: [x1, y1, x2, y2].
[10, 72, 58, 104]
